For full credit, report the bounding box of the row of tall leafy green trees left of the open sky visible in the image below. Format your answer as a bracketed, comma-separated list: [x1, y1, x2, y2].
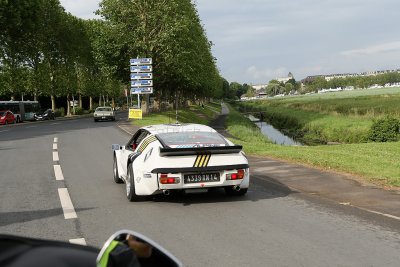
[0, 0, 224, 114]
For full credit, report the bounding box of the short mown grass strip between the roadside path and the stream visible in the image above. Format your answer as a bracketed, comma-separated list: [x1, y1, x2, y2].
[227, 103, 400, 187]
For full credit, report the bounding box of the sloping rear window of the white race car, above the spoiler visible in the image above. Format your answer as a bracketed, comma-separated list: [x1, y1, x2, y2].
[157, 132, 228, 148]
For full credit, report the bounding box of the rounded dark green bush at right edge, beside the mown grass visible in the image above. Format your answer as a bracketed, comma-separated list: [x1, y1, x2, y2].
[369, 117, 400, 142]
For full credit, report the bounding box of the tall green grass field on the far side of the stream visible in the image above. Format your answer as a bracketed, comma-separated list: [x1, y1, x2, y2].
[238, 88, 400, 144]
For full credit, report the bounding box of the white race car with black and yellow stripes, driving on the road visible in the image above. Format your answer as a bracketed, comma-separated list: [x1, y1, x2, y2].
[112, 124, 250, 201]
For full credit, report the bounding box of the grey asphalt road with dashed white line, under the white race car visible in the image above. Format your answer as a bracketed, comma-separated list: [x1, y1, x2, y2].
[0, 118, 400, 266]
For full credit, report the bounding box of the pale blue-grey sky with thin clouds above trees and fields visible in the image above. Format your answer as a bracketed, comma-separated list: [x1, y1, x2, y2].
[60, 0, 400, 84]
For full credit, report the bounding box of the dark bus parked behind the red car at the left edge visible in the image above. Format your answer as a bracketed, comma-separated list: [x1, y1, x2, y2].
[0, 101, 40, 123]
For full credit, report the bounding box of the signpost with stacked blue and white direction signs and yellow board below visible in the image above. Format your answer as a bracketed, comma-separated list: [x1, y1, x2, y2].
[129, 58, 153, 119]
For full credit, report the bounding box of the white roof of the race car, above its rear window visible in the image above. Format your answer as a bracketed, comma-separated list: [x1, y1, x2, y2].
[142, 123, 216, 134]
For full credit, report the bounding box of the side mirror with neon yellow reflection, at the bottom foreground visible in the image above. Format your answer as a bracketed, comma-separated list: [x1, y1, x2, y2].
[96, 230, 183, 267]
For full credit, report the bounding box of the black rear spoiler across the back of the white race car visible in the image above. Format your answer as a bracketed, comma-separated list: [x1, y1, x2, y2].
[160, 145, 243, 157]
